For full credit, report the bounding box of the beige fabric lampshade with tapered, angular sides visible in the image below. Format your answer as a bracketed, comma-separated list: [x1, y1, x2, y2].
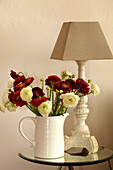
[51, 22, 113, 60]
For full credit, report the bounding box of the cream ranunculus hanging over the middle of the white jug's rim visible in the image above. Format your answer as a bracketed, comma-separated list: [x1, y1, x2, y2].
[38, 100, 52, 117]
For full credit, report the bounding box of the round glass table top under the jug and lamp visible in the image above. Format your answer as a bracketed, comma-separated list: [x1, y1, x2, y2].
[18, 147, 113, 166]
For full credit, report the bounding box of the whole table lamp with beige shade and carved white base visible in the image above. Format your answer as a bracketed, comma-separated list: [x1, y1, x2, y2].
[51, 22, 113, 153]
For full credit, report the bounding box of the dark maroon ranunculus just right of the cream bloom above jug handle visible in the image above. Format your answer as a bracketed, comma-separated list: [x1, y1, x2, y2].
[32, 87, 45, 99]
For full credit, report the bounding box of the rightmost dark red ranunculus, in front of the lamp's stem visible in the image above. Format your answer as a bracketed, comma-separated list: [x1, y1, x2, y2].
[74, 78, 89, 95]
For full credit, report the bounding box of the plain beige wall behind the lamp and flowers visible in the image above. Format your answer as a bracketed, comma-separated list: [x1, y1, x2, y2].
[0, 0, 113, 170]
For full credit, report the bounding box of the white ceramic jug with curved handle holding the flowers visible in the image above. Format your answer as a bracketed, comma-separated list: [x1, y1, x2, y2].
[19, 113, 69, 158]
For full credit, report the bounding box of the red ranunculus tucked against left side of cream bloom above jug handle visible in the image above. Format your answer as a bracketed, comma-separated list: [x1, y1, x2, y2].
[13, 91, 26, 107]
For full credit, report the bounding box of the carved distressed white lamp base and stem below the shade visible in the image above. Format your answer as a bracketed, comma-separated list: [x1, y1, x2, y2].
[65, 61, 99, 153]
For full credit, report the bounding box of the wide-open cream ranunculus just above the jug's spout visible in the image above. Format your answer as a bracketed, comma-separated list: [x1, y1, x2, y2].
[60, 93, 80, 107]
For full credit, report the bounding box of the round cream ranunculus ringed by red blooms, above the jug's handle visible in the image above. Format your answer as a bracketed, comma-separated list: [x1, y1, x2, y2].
[20, 86, 33, 102]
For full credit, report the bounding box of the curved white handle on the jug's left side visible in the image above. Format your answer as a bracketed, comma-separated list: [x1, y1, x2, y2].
[19, 116, 36, 147]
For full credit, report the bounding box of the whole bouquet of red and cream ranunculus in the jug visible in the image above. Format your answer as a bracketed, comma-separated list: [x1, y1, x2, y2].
[0, 70, 100, 117]
